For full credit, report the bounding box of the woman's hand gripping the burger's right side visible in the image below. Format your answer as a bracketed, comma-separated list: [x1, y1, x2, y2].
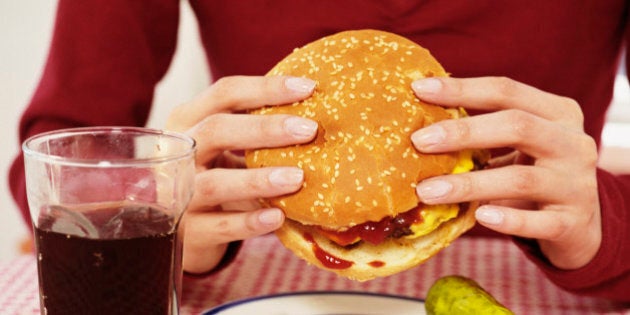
[412, 78, 602, 269]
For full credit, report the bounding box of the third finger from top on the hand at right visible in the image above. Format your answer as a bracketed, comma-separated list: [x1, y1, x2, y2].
[416, 165, 575, 204]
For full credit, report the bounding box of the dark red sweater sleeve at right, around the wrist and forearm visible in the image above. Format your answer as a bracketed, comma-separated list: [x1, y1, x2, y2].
[516, 169, 630, 302]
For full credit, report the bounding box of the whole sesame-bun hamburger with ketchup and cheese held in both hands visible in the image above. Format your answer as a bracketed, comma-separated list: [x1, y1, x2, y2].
[245, 30, 483, 281]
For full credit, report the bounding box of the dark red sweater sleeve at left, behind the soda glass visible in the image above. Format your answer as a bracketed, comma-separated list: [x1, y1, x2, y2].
[9, 0, 179, 227]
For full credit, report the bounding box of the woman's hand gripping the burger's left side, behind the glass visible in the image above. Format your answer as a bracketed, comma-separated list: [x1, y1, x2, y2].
[166, 76, 317, 273]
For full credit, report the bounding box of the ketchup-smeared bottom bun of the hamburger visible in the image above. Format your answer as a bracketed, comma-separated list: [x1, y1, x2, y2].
[276, 202, 478, 281]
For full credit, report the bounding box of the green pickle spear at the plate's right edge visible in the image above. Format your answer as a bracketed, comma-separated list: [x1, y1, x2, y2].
[424, 276, 514, 315]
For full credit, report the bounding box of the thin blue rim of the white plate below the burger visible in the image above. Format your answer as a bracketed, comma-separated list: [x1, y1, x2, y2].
[201, 290, 424, 315]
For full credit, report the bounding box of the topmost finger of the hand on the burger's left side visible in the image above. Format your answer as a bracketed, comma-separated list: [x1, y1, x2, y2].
[167, 76, 316, 132]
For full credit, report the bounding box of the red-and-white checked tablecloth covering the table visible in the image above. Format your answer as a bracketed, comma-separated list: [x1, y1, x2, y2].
[0, 235, 630, 315]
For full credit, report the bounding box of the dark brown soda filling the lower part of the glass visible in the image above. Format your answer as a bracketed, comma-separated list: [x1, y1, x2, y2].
[35, 204, 182, 315]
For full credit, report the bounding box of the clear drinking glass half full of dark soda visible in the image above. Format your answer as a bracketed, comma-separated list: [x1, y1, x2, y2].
[22, 127, 195, 315]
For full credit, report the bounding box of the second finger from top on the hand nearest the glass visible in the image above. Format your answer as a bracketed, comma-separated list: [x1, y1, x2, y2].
[188, 114, 318, 163]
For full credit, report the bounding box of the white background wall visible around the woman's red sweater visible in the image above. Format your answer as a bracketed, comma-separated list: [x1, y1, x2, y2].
[0, 0, 630, 261]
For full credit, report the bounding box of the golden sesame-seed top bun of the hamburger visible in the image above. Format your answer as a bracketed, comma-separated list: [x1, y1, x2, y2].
[245, 30, 457, 230]
